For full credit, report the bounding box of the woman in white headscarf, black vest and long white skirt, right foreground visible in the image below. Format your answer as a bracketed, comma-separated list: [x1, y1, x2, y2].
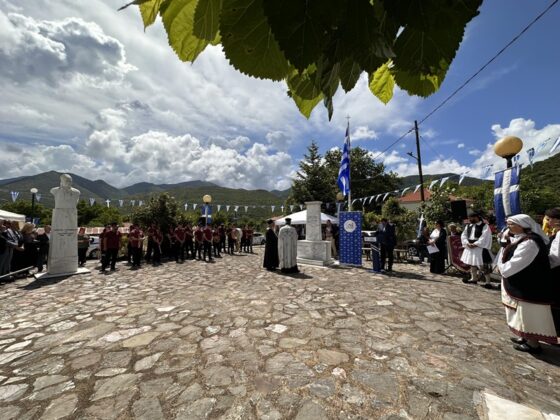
[498, 214, 560, 353]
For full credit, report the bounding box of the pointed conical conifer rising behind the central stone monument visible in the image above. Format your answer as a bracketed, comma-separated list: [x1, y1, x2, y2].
[289, 141, 335, 204]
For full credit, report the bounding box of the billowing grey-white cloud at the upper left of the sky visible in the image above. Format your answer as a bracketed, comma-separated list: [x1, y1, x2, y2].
[0, 11, 134, 86]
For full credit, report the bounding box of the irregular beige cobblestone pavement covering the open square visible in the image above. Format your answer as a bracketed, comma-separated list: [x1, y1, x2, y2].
[0, 250, 560, 420]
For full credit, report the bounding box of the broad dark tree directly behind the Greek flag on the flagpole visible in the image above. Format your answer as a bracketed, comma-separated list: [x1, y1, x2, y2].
[325, 147, 399, 211]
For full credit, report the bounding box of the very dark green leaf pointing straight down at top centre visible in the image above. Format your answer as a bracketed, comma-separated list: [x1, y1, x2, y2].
[263, 0, 346, 71]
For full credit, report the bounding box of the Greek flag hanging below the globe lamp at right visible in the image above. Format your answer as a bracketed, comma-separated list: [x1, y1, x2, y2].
[494, 168, 521, 230]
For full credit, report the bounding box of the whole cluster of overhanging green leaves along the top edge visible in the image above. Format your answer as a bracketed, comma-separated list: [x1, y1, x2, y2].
[121, 0, 482, 118]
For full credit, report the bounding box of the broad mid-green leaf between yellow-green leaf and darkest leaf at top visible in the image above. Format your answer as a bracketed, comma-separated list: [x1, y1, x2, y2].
[220, 0, 290, 80]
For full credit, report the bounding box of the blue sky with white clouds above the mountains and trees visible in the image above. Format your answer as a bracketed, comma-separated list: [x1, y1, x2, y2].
[0, 0, 560, 190]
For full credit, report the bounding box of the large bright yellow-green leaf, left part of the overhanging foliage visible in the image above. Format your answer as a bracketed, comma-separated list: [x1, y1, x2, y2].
[161, 0, 209, 61]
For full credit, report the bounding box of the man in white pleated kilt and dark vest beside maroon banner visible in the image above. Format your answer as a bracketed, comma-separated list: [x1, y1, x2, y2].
[461, 210, 492, 289]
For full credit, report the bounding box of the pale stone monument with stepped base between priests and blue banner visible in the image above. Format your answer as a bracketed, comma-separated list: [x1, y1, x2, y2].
[298, 201, 334, 266]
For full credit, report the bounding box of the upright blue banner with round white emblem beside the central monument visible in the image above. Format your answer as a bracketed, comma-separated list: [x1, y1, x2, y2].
[338, 211, 362, 266]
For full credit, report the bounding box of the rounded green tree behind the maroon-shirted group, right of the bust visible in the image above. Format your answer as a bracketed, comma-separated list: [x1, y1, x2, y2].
[131, 193, 179, 232]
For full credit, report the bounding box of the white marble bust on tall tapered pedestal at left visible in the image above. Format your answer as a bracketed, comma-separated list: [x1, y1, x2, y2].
[35, 174, 89, 279]
